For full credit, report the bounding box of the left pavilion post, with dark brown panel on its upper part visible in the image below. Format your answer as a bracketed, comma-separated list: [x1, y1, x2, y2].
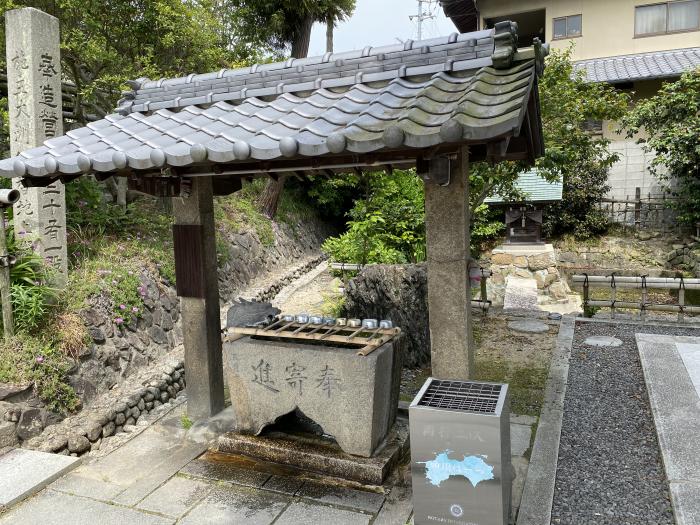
[173, 177, 224, 420]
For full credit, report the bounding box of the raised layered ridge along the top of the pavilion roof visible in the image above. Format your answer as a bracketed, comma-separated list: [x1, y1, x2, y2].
[116, 29, 495, 114]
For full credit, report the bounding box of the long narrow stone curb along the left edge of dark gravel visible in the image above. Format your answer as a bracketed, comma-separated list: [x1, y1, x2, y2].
[517, 315, 578, 525]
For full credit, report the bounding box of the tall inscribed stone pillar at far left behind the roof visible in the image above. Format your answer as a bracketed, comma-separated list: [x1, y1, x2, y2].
[5, 8, 68, 285]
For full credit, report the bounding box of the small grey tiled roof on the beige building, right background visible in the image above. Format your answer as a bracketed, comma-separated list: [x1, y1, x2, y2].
[574, 47, 700, 83]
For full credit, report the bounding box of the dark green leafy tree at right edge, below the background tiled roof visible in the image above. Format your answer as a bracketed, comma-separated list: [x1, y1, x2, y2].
[622, 68, 700, 226]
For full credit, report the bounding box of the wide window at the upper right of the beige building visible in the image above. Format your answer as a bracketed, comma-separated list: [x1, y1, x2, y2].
[634, 0, 700, 36]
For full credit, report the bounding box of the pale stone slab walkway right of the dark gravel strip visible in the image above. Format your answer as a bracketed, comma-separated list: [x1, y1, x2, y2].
[636, 334, 700, 525]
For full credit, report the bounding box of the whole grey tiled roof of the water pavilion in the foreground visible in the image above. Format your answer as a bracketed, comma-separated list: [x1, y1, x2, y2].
[0, 22, 546, 185]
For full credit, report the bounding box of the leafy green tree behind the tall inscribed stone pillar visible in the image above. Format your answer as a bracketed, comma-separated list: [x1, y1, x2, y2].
[0, 0, 236, 125]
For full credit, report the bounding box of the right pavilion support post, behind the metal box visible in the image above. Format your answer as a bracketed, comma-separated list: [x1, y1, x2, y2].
[425, 147, 474, 379]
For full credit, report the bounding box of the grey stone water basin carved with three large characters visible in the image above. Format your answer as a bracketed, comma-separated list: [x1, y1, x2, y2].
[224, 337, 401, 457]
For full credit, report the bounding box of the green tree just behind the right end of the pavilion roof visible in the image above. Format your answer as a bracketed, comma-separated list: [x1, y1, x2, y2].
[470, 48, 629, 238]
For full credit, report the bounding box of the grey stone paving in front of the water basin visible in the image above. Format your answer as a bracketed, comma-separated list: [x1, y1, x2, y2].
[0, 396, 534, 525]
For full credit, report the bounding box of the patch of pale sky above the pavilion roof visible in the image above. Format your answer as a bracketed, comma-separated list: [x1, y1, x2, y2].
[309, 0, 456, 56]
